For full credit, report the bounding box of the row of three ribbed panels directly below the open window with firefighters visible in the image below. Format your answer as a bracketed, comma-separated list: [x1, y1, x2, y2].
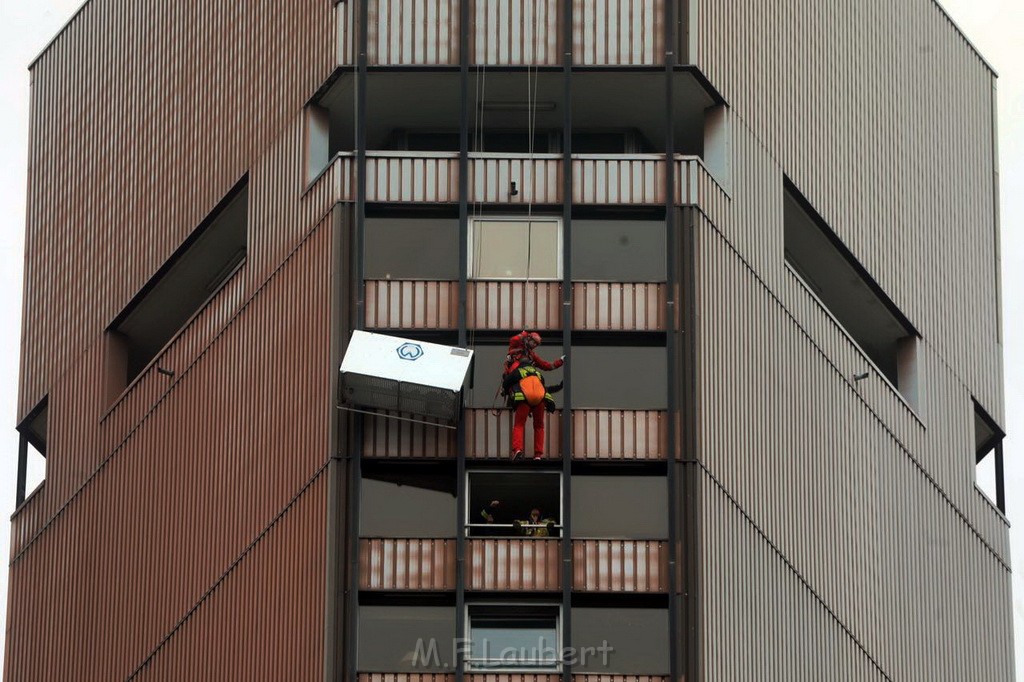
[359, 538, 669, 594]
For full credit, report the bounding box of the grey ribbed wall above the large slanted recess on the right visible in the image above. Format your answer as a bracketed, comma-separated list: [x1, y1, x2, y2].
[693, 0, 1005, 423]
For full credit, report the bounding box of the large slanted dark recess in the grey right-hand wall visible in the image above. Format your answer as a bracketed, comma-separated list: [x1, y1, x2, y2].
[784, 180, 920, 399]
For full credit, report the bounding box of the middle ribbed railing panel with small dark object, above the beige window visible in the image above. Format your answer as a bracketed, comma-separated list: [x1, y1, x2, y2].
[469, 154, 562, 204]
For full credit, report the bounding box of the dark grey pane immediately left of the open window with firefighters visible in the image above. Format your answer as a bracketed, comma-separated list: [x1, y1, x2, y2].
[359, 469, 456, 538]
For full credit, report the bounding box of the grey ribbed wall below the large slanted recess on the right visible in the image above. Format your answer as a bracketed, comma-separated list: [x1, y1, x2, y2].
[694, 216, 1012, 679]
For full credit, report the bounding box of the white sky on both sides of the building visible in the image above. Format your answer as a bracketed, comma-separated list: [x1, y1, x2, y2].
[0, 0, 1024, 680]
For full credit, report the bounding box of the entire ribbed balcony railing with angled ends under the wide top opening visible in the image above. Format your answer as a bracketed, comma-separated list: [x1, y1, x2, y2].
[310, 152, 721, 207]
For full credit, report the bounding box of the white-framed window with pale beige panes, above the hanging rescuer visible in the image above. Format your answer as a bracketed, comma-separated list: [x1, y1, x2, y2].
[469, 218, 562, 280]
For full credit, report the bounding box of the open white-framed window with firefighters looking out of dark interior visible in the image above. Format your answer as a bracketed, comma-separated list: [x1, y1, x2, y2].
[466, 470, 562, 539]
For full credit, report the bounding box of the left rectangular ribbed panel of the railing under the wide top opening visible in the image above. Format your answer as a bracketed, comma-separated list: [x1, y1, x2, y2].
[367, 152, 459, 204]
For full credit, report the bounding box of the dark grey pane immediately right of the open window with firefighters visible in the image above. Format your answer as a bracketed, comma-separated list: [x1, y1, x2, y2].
[572, 475, 669, 540]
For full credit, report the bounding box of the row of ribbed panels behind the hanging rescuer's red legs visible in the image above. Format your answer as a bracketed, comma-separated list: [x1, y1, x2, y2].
[362, 409, 669, 462]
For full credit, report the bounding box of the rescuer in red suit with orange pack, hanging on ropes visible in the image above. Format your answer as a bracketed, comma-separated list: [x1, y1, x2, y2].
[502, 331, 565, 461]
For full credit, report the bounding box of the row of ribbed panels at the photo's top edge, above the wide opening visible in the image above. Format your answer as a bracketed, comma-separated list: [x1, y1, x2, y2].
[337, 0, 671, 67]
